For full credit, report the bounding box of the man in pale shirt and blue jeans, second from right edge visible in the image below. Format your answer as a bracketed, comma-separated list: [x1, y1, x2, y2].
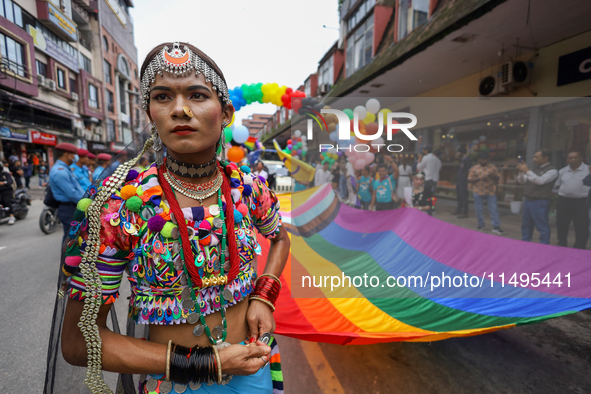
[517, 149, 558, 245]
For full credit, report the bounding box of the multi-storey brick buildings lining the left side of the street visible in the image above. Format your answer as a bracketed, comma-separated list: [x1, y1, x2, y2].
[0, 0, 143, 164]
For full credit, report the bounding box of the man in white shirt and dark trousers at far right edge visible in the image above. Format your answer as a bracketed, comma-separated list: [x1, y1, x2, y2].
[554, 151, 589, 249]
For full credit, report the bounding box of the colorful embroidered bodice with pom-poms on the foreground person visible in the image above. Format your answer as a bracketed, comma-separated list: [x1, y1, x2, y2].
[63, 164, 281, 324]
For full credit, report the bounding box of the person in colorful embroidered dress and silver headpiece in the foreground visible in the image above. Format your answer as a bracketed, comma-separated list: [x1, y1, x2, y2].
[54, 42, 290, 394]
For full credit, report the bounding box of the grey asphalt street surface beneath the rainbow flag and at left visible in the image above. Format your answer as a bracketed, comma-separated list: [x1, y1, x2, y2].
[0, 200, 591, 394]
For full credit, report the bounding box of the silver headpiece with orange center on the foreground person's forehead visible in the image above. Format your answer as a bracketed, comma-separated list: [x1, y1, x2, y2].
[141, 42, 232, 111]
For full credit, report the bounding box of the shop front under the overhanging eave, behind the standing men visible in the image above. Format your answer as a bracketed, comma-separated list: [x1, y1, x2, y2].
[417, 97, 591, 204]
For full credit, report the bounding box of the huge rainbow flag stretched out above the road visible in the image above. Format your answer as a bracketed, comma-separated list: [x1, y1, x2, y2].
[259, 185, 591, 345]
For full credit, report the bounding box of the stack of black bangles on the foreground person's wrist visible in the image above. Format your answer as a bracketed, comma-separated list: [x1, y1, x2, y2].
[170, 345, 218, 385]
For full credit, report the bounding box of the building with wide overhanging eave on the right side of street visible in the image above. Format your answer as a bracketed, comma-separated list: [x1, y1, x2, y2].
[260, 0, 591, 202]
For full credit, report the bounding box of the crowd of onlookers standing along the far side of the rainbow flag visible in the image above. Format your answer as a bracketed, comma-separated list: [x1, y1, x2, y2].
[294, 145, 591, 249]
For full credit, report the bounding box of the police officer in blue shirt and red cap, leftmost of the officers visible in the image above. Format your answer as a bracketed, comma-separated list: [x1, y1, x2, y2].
[49, 142, 84, 239]
